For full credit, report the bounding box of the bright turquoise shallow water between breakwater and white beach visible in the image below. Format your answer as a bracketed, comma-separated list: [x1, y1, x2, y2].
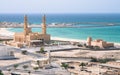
[9, 26, 120, 43]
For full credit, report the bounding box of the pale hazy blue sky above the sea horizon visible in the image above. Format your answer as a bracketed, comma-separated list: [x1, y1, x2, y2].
[0, 0, 120, 13]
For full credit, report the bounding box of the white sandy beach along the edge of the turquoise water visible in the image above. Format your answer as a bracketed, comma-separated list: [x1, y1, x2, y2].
[0, 28, 120, 46]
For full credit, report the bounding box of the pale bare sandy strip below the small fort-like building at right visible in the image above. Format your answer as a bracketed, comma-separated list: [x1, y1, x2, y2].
[51, 49, 120, 59]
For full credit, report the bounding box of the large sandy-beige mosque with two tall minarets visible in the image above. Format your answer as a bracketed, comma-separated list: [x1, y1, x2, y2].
[5, 15, 50, 47]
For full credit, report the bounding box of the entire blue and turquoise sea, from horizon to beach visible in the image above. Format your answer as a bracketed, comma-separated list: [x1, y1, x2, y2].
[0, 13, 120, 43]
